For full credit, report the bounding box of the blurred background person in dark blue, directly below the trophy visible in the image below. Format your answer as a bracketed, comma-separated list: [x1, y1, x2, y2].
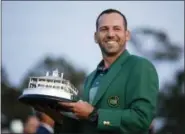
[36, 112, 54, 134]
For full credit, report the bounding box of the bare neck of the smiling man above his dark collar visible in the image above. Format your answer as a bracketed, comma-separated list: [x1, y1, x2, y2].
[103, 49, 125, 68]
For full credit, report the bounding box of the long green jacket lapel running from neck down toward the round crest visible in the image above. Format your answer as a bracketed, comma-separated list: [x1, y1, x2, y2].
[91, 50, 130, 106]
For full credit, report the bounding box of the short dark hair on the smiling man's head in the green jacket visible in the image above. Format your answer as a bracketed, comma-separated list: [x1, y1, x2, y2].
[96, 9, 127, 30]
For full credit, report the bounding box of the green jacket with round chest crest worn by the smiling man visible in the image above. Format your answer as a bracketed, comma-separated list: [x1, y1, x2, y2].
[55, 50, 159, 134]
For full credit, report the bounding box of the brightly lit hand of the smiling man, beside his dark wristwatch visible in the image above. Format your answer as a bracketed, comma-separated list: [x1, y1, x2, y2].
[59, 100, 94, 119]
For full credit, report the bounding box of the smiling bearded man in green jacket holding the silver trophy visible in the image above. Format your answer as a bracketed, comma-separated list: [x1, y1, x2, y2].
[55, 9, 159, 134]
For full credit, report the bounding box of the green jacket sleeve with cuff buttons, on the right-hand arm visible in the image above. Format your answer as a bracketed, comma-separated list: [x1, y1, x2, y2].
[98, 59, 159, 134]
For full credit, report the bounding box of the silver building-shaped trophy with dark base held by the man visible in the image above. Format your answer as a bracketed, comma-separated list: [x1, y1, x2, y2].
[19, 69, 79, 120]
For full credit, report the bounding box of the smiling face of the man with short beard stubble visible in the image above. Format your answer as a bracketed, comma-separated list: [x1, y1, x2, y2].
[95, 13, 129, 56]
